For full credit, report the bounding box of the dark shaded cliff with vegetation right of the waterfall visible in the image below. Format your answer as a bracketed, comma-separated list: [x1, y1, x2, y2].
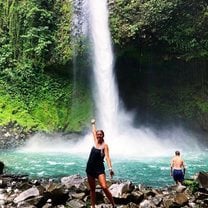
[110, 0, 208, 130]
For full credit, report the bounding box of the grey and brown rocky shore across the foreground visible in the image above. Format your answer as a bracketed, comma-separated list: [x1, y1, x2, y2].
[0, 173, 208, 208]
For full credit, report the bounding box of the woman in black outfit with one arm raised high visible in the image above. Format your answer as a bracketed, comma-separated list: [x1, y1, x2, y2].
[86, 119, 115, 208]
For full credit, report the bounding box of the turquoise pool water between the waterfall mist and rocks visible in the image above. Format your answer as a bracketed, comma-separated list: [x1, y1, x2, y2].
[0, 150, 208, 187]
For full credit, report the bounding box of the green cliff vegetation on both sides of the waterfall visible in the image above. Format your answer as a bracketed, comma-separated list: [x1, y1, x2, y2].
[0, 0, 208, 132]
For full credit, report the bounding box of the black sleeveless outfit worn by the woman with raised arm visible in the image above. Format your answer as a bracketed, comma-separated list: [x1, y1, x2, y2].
[86, 147, 105, 178]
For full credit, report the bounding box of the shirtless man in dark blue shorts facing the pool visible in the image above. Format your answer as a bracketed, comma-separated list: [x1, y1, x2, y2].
[170, 151, 185, 185]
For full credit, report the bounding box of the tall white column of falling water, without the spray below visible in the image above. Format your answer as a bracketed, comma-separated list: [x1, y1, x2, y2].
[89, 0, 119, 136]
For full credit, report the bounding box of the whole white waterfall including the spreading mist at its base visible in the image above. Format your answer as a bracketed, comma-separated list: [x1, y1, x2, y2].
[20, 0, 202, 158]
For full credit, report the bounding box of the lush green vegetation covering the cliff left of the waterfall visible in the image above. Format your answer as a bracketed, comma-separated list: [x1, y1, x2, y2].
[0, 0, 92, 131]
